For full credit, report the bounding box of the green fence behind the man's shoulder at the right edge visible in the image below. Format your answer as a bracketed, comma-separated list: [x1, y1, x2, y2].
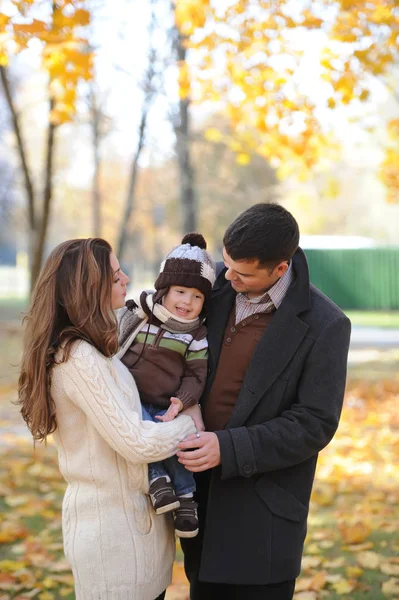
[304, 247, 399, 310]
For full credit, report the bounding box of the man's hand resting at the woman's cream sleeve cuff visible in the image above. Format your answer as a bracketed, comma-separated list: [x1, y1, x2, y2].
[177, 431, 221, 473]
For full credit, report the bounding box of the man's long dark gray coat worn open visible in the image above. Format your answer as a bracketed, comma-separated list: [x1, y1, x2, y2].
[182, 249, 350, 584]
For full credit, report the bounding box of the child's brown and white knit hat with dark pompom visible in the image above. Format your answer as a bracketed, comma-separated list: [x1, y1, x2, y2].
[154, 233, 216, 298]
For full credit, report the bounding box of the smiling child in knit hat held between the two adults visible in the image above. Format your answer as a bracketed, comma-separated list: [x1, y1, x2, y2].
[117, 233, 215, 537]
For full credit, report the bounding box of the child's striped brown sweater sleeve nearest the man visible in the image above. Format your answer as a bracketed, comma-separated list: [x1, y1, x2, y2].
[175, 337, 208, 410]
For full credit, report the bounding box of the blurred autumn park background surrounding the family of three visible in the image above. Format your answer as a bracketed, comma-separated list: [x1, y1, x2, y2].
[0, 0, 399, 600]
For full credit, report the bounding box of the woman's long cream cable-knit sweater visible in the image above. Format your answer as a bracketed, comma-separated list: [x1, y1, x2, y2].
[51, 341, 195, 600]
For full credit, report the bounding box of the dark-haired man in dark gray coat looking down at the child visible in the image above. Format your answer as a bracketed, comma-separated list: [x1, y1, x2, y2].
[178, 204, 350, 600]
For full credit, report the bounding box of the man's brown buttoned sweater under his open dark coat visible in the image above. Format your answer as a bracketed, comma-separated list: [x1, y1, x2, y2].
[204, 308, 275, 431]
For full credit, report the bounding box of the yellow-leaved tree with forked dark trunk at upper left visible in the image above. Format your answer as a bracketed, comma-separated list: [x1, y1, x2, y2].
[0, 0, 92, 287]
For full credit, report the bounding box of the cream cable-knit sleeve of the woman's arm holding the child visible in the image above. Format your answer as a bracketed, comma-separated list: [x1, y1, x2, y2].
[57, 342, 196, 464]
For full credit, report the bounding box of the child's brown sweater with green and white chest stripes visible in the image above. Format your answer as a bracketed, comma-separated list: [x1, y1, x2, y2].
[118, 308, 208, 409]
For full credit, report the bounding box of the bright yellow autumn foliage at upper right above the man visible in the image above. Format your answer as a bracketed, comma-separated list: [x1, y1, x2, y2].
[176, 0, 399, 202]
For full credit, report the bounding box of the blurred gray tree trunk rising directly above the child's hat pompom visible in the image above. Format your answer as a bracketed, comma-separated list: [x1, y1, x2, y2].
[174, 28, 197, 233]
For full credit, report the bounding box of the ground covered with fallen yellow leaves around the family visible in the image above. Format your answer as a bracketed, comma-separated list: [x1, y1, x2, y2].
[0, 328, 399, 600]
